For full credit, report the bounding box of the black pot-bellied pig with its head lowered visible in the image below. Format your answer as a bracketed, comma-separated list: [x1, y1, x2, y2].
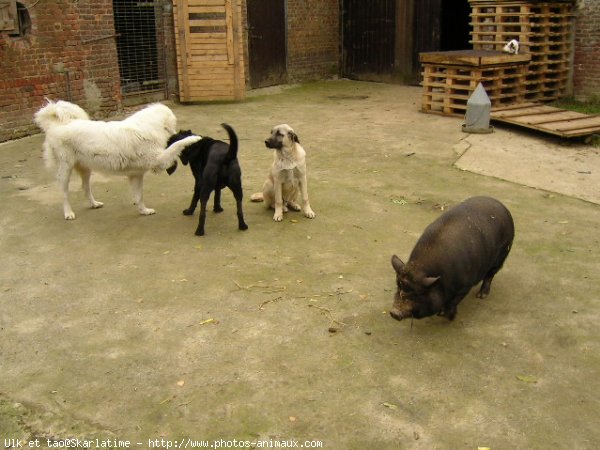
[390, 197, 515, 320]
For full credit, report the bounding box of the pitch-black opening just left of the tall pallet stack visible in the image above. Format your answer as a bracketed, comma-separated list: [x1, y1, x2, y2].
[440, 0, 471, 51]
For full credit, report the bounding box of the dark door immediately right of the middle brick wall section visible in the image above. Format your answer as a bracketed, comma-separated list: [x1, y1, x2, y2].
[342, 0, 396, 80]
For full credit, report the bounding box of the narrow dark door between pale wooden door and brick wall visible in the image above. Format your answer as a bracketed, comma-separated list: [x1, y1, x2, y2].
[247, 0, 287, 88]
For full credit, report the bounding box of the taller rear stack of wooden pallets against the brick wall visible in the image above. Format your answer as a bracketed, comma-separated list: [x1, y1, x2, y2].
[470, 0, 574, 102]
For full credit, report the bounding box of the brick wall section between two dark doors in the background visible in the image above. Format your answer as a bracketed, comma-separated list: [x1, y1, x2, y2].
[287, 0, 340, 82]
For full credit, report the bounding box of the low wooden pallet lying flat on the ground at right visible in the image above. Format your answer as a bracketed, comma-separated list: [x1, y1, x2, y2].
[491, 103, 600, 138]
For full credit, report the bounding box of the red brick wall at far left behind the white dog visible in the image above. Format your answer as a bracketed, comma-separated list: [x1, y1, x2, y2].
[0, 0, 121, 142]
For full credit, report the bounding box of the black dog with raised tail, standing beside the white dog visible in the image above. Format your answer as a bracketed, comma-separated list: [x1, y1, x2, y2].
[167, 123, 248, 236]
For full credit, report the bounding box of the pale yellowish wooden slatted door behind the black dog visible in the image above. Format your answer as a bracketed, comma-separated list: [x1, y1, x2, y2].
[173, 0, 246, 102]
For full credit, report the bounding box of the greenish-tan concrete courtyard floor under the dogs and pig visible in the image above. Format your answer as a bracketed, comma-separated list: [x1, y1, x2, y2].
[0, 80, 600, 450]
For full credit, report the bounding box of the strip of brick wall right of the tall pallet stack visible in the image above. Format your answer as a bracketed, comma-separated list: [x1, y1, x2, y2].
[573, 0, 600, 100]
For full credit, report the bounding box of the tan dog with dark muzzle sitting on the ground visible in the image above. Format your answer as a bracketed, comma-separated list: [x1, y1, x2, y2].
[251, 124, 315, 222]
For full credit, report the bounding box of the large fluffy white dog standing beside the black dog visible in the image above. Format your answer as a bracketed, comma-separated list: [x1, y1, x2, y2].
[34, 100, 201, 220]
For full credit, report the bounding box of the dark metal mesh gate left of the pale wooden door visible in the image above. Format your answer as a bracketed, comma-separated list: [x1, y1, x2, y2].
[113, 0, 166, 98]
